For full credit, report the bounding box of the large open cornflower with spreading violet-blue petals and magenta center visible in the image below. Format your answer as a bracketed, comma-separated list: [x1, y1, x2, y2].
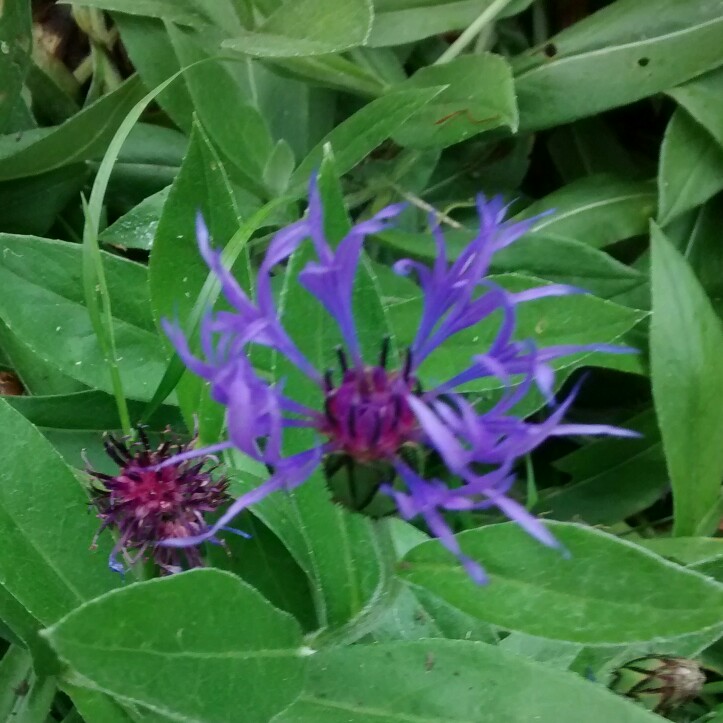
[161, 179, 630, 583]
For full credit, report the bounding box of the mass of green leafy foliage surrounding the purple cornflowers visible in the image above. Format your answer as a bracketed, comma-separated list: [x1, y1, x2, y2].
[0, 0, 723, 723]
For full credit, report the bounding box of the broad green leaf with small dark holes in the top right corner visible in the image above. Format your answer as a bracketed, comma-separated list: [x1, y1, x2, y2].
[513, 0, 723, 130]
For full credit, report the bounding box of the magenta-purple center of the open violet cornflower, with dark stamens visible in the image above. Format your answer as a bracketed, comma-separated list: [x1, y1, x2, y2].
[320, 339, 418, 462]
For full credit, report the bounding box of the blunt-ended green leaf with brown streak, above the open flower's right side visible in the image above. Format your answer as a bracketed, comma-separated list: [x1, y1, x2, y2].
[393, 53, 518, 149]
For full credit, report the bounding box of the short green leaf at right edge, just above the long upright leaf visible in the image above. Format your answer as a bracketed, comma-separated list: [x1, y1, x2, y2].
[658, 109, 723, 224]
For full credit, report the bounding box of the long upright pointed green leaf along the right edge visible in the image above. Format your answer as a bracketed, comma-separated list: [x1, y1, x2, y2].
[650, 224, 723, 536]
